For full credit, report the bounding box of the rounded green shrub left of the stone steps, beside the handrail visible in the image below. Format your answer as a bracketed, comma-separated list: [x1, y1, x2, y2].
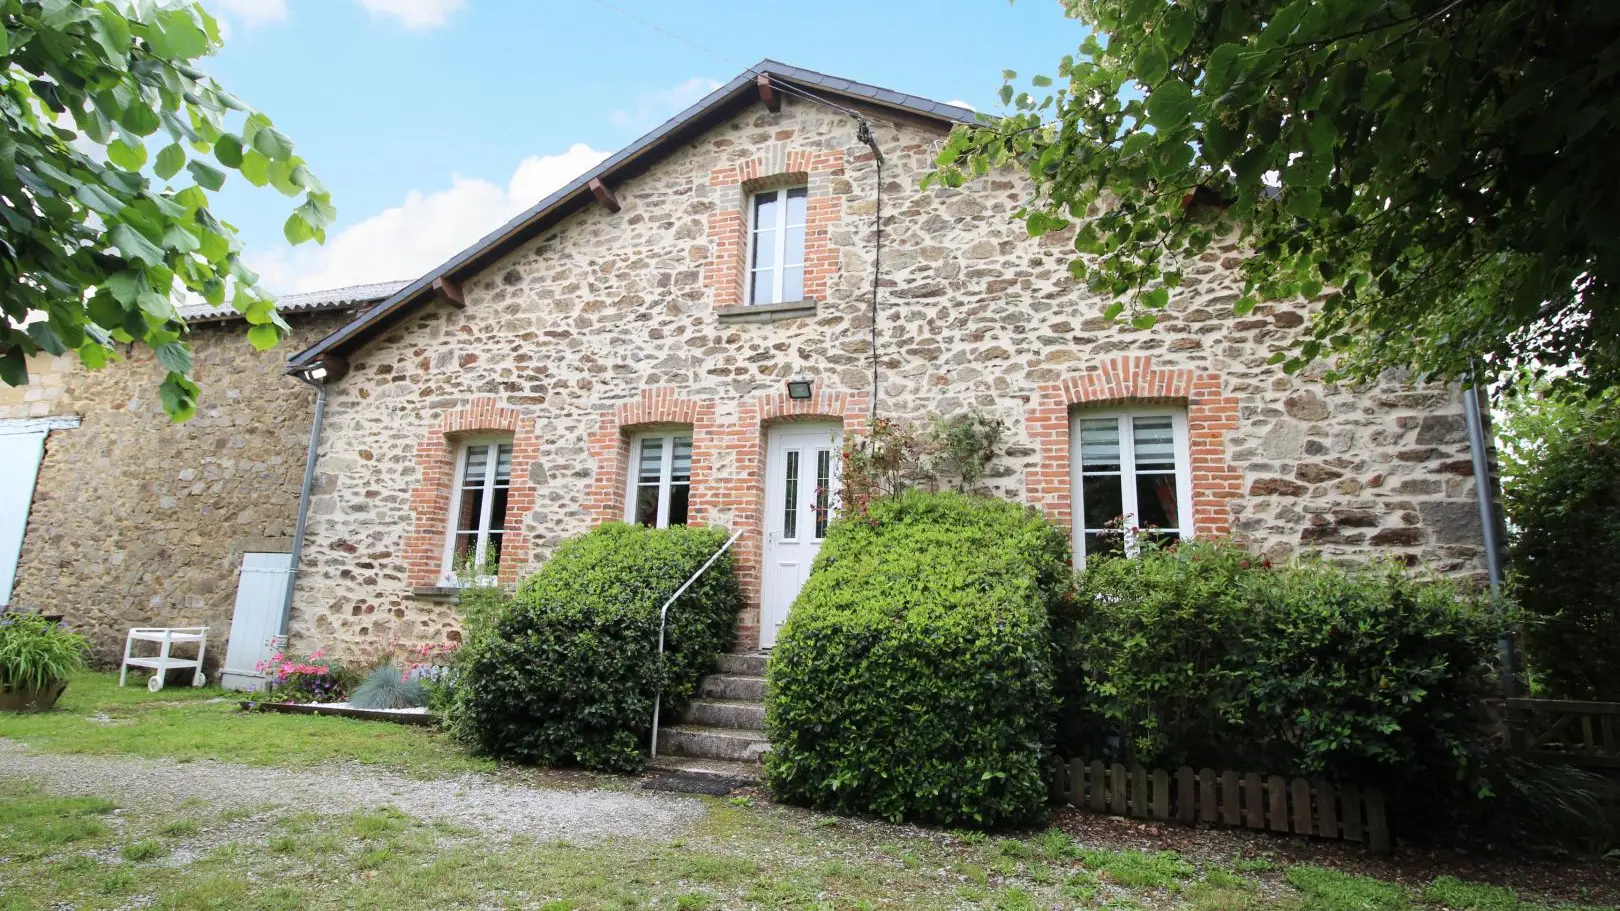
[454, 524, 742, 772]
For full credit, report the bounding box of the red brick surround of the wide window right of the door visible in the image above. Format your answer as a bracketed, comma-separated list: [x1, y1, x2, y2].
[1024, 357, 1243, 537]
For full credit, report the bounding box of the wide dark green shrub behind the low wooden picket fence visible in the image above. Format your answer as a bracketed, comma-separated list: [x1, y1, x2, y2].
[1064, 541, 1503, 785]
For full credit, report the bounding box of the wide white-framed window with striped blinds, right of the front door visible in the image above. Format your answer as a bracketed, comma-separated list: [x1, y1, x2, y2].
[1069, 408, 1192, 561]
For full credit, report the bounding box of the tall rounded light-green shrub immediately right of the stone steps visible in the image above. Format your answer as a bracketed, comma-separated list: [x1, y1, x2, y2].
[765, 491, 1068, 827]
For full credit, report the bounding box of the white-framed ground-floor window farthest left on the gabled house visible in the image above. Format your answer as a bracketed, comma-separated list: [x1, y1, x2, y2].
[444, 439, 512, 580]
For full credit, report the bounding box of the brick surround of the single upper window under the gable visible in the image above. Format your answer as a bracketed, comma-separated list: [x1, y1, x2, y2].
[703, 144, 844, 308]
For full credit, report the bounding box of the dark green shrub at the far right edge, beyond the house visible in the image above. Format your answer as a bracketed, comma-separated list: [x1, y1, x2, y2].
[1507, 417, 1620, 700]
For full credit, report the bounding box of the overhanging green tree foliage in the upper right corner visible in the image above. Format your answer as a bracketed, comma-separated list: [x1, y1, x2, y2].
[930, 0, 1620, 384]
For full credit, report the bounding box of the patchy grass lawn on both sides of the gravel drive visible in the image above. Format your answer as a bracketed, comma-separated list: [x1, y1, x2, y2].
[0, 674, 1613, 911]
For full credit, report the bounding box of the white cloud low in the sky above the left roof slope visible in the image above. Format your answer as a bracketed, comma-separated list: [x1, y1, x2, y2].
[249, 143, 608, 293]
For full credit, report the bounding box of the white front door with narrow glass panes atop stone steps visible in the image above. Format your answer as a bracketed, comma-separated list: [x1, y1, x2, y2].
[760, 423, 842, 648]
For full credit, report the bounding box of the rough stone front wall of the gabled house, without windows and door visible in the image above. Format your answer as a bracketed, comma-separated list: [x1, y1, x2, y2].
[293, 97, 1481, 647]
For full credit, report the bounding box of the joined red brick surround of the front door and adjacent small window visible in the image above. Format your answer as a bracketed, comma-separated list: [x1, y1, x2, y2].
[586, 384, 870, 648]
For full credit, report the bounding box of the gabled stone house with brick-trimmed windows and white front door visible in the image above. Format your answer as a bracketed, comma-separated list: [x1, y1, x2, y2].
[278, 60, 1484, 667]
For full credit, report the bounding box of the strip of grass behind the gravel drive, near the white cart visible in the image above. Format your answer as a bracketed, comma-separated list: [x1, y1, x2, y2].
[0, 673, 494, 776]
